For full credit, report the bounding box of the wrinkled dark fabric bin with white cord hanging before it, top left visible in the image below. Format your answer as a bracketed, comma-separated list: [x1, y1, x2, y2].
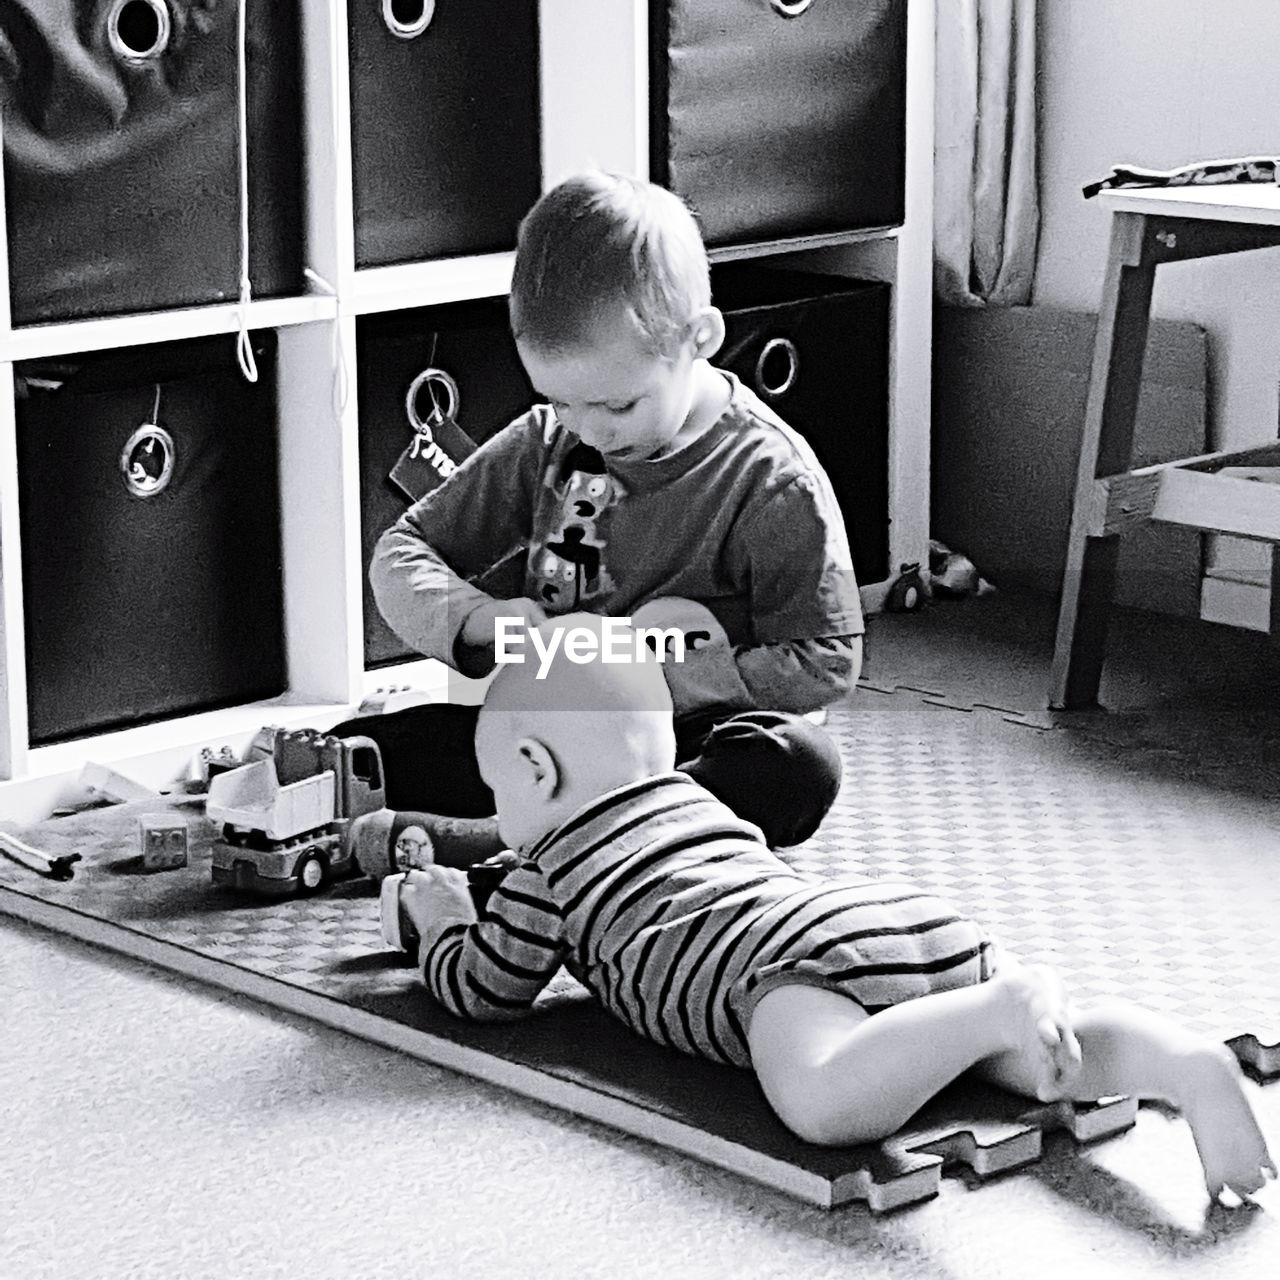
[0, 0, 303, 324]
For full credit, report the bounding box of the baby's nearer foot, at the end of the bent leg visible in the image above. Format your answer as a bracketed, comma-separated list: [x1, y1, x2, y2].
[988, 956, 1080, 1102]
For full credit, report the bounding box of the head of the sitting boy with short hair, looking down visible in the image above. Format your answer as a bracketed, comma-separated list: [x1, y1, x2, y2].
[511, 172, 724, 457]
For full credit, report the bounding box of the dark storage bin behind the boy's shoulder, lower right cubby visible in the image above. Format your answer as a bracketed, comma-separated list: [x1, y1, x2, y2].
[712, 264, 890, 585]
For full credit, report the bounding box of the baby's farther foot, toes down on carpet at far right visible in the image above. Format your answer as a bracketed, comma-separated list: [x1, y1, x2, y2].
[1179, 1044, 1276, 1199]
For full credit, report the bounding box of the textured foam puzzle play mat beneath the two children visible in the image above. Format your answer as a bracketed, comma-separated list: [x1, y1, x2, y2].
[0, 650, 1280, 1211]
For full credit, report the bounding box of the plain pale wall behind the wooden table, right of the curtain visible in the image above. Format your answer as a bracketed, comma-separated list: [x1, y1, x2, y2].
[1034, 0, 1280, 599]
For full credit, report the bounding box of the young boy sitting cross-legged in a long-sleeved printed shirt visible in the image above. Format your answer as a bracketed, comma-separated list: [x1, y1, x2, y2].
[334, 165, 863, 855]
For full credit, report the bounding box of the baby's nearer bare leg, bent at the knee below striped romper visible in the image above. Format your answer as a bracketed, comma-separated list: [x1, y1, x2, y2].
[748, 975, 1060, 1146]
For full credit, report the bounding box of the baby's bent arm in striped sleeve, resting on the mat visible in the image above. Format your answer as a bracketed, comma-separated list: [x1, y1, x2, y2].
[415, 864, 566, 1021]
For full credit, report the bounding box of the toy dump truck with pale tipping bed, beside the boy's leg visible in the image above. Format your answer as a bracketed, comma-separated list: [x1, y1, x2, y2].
[205, 728, 385, 897]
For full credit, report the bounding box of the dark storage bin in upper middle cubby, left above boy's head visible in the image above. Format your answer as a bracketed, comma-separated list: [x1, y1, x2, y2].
[348, 0, 541, 266]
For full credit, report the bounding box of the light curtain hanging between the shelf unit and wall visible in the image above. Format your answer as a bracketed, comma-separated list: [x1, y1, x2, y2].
[933, 0, 1039, 306]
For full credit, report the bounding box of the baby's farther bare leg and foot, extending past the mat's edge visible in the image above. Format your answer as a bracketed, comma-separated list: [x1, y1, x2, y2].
[982, 970, 1276, 1198]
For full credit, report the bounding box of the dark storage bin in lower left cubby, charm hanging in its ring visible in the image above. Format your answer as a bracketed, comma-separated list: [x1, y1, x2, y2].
[15, 334, 285, 744]
